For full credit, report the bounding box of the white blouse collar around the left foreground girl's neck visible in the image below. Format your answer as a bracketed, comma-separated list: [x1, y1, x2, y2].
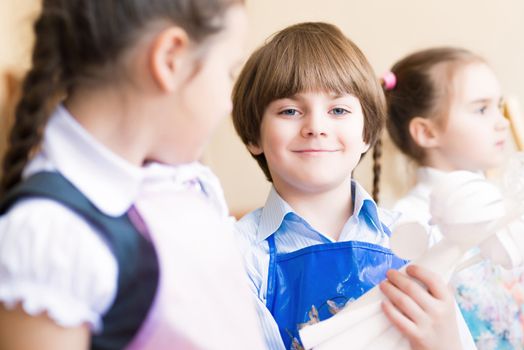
[24, 105, 143, 216]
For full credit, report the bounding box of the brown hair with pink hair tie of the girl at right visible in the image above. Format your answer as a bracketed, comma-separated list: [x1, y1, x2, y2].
[373, 47, 485, 200]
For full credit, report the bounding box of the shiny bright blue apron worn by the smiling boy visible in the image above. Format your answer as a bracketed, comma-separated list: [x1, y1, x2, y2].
[267, 231, 406, 349]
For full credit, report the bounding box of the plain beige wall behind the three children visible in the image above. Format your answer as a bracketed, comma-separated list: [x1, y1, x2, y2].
[0, 0, 524, 214]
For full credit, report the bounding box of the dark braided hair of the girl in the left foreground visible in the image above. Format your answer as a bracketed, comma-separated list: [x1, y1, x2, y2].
[0, 0, 243, 194]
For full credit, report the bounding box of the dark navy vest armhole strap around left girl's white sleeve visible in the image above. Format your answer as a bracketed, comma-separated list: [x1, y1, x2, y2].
[0, 172, 159, 350]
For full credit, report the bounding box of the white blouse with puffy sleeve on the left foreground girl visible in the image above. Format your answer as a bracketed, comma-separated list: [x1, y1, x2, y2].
[0, 106, 227, 332]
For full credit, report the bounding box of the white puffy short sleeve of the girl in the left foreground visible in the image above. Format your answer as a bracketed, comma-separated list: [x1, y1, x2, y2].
[0, 199, 118, 329]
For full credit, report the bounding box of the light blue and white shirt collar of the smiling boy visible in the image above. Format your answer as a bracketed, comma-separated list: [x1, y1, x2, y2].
[257, 180, 399, 242]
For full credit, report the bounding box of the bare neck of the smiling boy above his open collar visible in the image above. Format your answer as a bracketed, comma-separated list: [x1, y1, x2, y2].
[275, 182, 353, 241]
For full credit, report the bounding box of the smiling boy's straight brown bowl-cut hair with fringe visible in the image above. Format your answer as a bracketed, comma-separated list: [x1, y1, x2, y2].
[233, 22, 386, 181]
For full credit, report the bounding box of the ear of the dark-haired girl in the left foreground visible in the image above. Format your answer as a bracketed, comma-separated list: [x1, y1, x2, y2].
[149, 26, 189, 91]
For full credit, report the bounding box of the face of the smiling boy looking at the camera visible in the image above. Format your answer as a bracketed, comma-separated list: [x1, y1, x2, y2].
[248, 92, 369, 198]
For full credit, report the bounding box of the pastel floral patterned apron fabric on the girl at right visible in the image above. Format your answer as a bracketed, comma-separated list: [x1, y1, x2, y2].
[451, 261, 524, 350]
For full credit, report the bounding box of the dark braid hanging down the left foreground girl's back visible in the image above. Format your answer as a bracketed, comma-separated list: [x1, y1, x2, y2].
[0, 8, 66, 195]
